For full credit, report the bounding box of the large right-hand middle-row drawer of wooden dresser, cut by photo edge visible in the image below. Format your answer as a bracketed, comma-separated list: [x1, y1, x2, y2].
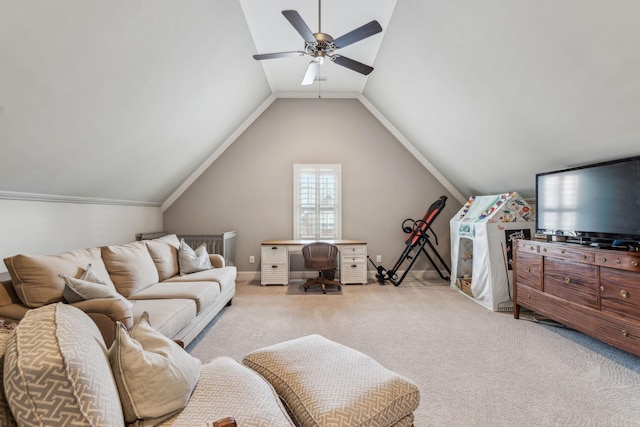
[600, 267, 640, 321]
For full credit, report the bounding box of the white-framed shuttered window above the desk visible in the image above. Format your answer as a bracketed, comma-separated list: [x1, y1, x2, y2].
[293, 164, 342, 240]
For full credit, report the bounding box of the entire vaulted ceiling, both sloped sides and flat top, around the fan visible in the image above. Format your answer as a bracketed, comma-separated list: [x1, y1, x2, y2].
[0, 0, 640, 204]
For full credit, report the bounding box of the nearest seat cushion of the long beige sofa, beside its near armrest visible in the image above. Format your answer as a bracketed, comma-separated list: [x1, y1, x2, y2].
[131, 299, 197, 337]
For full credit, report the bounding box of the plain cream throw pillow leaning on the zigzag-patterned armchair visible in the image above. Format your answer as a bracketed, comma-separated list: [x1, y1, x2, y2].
[109, 312, 201, 426]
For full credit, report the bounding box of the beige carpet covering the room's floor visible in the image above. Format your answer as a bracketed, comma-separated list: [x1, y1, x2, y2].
[188, 281, 640, 427]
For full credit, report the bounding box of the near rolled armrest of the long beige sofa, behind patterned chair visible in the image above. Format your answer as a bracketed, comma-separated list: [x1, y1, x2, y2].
[71, 298, 133, 348]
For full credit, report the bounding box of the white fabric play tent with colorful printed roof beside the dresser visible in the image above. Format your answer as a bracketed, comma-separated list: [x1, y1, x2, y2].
[450, 192, 535, 311]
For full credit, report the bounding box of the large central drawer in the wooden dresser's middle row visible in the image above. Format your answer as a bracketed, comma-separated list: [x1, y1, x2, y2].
[544, 258, 598, 308]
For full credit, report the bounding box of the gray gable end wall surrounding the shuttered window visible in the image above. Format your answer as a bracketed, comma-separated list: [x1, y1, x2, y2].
[164, 99, 461, 280]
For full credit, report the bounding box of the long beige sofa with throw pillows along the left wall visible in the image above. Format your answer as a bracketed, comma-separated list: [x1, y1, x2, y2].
[0, 234, 237, 347]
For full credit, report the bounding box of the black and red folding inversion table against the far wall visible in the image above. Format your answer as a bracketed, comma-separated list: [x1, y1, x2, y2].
[367, 196, 451, 286]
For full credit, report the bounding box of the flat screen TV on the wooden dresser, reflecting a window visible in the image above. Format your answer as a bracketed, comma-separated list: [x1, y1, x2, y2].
[536, 156, 640, 248]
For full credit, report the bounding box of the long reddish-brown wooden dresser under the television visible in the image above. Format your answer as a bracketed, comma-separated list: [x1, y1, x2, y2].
[513, 240, 640, 356]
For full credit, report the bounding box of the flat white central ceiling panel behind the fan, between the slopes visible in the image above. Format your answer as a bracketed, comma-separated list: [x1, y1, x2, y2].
[240, 0, 396, 97]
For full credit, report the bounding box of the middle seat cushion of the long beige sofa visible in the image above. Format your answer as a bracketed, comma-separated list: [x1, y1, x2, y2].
[129, 282, 220, 313]
